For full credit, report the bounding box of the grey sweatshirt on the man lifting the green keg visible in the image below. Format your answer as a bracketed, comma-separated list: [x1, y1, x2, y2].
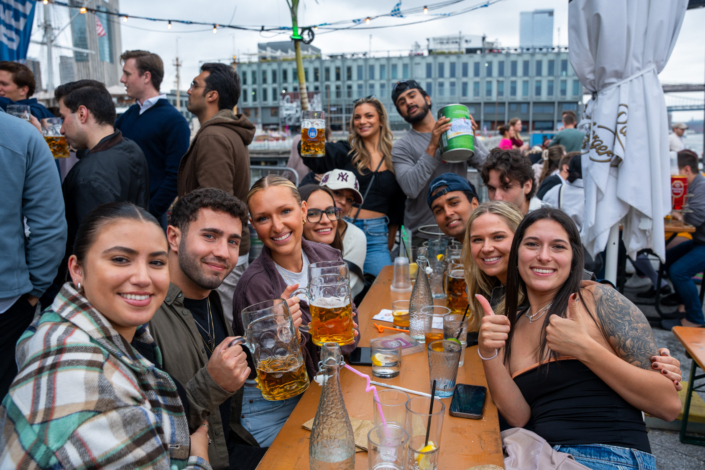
[392, 129, 489, 238]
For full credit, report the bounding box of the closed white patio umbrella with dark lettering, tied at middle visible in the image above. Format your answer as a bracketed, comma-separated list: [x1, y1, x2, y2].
[568, 0, 688, 282]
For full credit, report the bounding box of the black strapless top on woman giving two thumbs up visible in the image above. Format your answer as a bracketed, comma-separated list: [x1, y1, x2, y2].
[514, 359, 651, 453]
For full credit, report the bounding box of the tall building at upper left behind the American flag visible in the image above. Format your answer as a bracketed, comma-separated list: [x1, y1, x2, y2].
[69, 0, 122, 87]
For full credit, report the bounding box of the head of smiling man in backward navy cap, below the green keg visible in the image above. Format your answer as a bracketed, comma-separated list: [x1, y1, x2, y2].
[427, 173, 480, 243]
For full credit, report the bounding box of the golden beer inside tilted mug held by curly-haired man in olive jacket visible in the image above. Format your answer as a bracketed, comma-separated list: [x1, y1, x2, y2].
[257, 356, 309, 401]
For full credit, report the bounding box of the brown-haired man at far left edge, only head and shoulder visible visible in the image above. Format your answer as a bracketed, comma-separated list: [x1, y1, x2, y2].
[0, 61, 54, 121]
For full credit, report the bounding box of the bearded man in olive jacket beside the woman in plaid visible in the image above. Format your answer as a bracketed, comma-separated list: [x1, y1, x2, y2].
[149, 188, 286, 469]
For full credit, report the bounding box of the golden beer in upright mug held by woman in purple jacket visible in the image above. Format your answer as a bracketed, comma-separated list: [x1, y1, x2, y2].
[309, 298, 355, 346]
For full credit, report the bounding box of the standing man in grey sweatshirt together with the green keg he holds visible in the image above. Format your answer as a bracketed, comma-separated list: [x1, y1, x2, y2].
[392, 80, 489, 247]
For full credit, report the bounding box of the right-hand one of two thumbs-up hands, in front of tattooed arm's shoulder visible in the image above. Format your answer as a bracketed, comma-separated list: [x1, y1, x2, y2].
[546, 294, 594, 359]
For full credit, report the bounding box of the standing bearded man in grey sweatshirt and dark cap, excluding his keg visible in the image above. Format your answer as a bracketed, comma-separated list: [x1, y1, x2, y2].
[392, 80, 489, 247]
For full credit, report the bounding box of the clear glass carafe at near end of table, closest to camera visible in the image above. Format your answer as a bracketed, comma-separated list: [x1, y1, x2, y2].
[308, 342, 355, 470]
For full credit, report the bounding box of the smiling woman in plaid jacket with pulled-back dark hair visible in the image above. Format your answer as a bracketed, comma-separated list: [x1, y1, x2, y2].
[0, 203, 211, 470]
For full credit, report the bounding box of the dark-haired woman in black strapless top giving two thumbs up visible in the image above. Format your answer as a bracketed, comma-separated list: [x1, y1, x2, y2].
[478, 209, 681, 470]
